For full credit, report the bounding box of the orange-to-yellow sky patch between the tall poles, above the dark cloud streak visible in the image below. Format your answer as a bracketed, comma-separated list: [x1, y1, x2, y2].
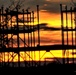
[40, 11, 61, 27]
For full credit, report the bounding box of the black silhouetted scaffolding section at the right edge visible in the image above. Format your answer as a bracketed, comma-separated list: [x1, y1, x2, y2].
[60, 4, 76, 64]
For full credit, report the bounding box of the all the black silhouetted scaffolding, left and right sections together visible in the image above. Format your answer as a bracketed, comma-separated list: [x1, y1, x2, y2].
[0, 4, 76, 67]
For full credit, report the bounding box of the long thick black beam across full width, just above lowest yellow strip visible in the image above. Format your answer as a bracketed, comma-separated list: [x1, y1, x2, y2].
[0, 45, 76, 52]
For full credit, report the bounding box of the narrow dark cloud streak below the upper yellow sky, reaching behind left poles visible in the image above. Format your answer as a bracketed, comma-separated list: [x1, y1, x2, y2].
[15, 23, 61, 32]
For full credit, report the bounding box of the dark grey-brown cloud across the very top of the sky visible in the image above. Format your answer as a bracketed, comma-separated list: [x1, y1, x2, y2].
[0, 0, 71, 13]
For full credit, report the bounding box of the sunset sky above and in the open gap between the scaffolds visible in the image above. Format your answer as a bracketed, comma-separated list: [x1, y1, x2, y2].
[0, 0, 75, 60]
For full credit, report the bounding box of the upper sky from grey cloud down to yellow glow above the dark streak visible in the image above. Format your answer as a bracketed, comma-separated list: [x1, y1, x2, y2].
[0, 0, 75, 27]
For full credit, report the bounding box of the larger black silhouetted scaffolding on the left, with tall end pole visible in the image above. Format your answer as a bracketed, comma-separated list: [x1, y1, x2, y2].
[0, 5, 57, 67]
